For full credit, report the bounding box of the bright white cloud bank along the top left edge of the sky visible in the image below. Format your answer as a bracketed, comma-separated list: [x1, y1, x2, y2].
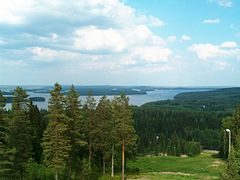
[0, 0, 165, 26]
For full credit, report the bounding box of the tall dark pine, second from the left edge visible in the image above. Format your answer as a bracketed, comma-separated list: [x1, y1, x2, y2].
[9, 87, 32, 179]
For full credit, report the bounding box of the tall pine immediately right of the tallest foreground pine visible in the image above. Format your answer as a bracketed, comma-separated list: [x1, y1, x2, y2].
[66, 86, 86, 179]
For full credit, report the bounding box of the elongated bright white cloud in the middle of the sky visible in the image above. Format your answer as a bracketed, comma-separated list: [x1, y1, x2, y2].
[74, 25, 165, 52]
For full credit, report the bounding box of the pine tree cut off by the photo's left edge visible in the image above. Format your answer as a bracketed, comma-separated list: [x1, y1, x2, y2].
[0, 91, 15, 179]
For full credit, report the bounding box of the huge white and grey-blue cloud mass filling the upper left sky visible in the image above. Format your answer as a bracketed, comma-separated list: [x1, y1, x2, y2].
[0, 0, 176, 75]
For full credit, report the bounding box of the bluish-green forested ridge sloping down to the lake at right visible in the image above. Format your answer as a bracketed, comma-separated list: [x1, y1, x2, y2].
[142, 87, 240, 112]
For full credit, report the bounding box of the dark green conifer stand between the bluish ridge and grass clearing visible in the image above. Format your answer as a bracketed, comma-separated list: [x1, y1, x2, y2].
[134, 107, 222, 155]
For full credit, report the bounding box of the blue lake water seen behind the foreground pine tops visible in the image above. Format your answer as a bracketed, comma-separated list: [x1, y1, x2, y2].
[6, 88, 209, 109]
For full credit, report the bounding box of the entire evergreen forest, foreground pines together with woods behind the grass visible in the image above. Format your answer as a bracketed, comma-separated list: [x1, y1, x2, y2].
[0, 83, 240, 180]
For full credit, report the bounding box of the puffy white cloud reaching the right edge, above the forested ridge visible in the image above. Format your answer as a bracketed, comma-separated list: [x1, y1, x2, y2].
[188, 42, 240, 60]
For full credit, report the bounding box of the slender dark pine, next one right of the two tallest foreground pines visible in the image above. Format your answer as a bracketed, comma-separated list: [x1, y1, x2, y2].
[83, 91, 96, 166]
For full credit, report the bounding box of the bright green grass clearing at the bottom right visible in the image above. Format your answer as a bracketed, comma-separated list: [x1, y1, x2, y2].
[100, 151, 225, 180]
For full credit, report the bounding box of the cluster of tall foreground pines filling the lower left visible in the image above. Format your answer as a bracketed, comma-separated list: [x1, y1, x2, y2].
[0, 84, 137, 180]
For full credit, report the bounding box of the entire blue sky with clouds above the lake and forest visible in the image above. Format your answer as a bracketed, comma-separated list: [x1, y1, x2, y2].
[0, 0, 240, 86]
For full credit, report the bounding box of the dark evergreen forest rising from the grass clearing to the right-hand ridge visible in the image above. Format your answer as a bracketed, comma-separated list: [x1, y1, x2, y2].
[134, 88, 240, 156]
